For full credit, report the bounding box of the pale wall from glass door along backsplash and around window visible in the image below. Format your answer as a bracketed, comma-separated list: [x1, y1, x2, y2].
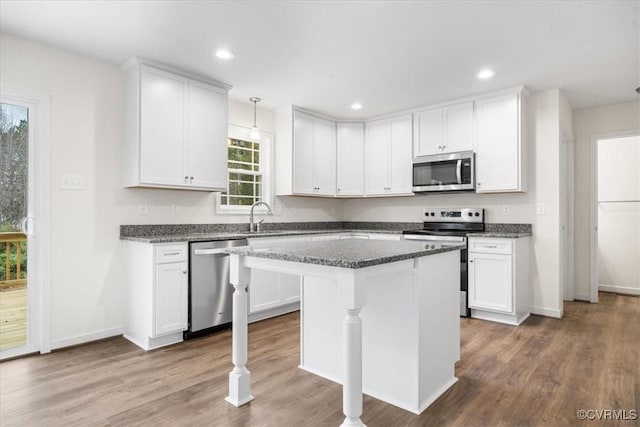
[0, 33, 341, 348]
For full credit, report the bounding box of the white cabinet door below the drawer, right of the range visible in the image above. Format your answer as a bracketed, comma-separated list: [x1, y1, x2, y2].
[469, 252, 514, 313]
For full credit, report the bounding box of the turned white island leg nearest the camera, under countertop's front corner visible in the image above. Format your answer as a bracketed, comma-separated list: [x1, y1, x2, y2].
[338, 269, 366, 427]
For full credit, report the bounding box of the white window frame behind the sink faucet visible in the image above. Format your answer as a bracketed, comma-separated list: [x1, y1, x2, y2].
[216, 125, 274, 215]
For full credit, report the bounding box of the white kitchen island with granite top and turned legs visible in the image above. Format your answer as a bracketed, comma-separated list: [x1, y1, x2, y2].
[226, 239, 464, 426]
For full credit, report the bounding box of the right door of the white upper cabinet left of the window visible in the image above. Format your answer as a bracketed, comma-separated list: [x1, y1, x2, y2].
[186, 81, 229, 188]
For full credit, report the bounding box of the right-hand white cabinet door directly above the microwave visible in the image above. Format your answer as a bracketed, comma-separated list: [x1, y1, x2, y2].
[442, 102, 473, 153]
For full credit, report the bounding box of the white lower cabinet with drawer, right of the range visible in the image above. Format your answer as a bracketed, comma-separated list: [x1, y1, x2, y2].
[468, 237, 530, 325]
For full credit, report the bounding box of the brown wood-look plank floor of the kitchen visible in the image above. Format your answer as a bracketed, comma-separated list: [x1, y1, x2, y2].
[0, 293, 640, 427]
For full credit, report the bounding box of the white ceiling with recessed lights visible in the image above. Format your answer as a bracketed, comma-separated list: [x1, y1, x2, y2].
[0, 0, 640, 119]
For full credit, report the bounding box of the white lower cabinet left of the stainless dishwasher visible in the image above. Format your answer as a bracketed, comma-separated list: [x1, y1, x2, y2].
[123, 241, 189, 350]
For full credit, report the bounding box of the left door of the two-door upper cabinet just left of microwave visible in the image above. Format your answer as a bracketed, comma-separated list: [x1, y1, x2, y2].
[365, 120, 391, 196]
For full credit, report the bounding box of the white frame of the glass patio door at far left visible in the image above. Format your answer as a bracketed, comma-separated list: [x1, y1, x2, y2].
[0, 85, 52, 359]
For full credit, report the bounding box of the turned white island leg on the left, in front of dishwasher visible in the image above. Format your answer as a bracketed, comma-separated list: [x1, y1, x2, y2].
[225, 254, 253, 406]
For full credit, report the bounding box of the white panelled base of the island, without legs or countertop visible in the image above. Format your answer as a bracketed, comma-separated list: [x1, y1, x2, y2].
[300, 251, 460, 414]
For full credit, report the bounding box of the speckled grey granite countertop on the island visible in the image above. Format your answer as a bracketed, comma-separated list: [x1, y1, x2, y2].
[225, 239, 466, 268]
